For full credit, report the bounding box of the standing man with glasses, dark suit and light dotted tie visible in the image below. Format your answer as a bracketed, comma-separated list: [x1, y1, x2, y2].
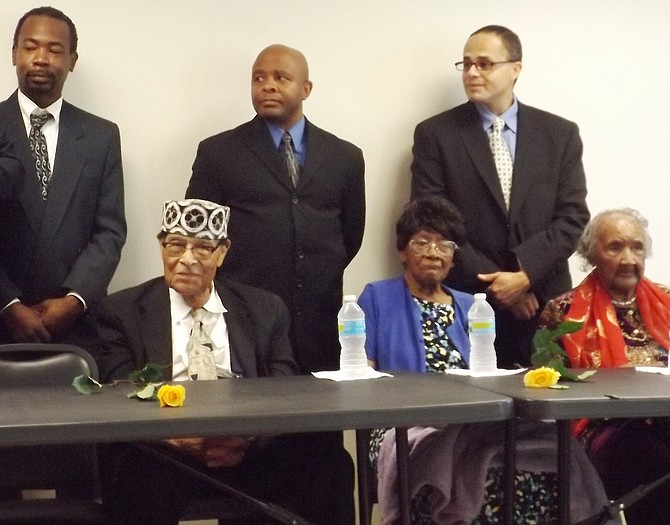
[412, 26, 589, 367]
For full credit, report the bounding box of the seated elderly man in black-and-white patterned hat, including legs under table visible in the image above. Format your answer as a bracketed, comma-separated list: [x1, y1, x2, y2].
[98, 199, 353, 525]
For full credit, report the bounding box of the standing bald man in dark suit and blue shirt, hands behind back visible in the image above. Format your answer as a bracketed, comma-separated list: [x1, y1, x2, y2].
[186, 45, 365, 373]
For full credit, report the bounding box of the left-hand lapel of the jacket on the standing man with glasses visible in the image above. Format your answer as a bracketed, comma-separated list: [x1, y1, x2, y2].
[458, 103, 516, 215]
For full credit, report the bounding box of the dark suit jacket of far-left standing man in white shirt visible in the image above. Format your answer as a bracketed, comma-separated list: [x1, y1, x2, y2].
[0, 92, 126, 322]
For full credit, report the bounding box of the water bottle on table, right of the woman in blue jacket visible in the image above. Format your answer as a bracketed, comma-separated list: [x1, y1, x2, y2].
[468, 293, 498, 376]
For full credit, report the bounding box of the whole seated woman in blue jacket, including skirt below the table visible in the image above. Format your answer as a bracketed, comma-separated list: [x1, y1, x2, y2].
[358, 196, 607, 525]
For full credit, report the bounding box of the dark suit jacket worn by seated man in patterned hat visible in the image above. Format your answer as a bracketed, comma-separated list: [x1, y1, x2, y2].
[96, 277, 296, 381]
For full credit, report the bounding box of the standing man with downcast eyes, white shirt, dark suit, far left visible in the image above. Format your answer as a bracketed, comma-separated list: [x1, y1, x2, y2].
[0, 7, 126, 347]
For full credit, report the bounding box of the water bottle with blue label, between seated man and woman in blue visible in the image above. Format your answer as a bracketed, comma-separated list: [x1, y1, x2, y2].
[337, 295, 368, 372]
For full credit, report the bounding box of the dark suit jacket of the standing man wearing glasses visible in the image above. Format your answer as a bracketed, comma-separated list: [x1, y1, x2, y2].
[412, 102, 589, 302]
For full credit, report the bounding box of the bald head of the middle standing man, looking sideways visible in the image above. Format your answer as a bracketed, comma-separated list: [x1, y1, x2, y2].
[251, 44, 312, 130]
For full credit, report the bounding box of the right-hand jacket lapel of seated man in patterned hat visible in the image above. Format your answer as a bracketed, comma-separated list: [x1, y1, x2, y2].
[215, 282, 258, 377]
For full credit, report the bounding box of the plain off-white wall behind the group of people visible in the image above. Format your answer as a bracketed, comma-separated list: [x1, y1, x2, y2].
[0, 0, 670, 293]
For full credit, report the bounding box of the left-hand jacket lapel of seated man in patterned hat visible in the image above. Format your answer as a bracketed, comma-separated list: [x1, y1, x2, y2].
[139, 278, 172, 378]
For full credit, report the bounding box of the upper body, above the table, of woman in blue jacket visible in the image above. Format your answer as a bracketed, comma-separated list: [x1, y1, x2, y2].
[358, 197, 474, 373]
